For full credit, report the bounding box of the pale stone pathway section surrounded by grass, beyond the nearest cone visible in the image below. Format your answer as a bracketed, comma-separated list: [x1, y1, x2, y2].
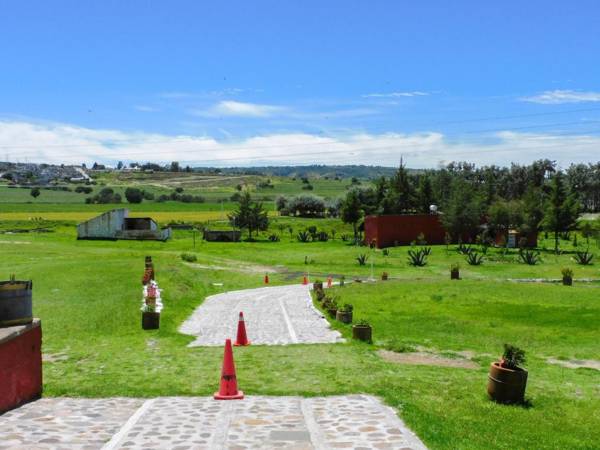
[179, 284, 343, 347]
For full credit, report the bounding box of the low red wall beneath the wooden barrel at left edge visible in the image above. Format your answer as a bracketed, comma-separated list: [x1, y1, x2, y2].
[0, 319, 42, 414]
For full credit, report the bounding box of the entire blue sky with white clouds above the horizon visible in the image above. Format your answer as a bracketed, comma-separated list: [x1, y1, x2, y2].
[0, 0, 600, 167]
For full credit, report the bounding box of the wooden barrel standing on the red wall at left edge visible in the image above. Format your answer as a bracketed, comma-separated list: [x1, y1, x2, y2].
[0, 280, 33, 327]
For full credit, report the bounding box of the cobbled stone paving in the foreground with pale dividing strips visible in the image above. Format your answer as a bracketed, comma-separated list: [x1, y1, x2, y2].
[0, 395, 426, 450]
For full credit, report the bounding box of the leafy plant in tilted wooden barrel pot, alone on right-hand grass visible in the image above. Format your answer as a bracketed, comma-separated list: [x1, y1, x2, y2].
[487, 344, 527, 403]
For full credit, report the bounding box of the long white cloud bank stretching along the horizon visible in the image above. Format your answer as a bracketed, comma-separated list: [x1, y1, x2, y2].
[0, 120, 600, 168]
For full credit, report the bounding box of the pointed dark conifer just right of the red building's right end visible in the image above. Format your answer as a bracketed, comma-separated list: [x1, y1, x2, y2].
[542, 172, 579, 253]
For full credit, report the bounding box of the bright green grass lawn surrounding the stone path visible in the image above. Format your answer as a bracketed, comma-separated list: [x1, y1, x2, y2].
[0, 223, 600, 449]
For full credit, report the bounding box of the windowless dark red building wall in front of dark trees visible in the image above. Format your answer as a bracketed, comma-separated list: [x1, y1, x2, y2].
[365, 214, 446, 248]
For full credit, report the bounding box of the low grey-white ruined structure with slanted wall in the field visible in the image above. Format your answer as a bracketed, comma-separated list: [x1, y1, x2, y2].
[77, 208, 171, 241]
